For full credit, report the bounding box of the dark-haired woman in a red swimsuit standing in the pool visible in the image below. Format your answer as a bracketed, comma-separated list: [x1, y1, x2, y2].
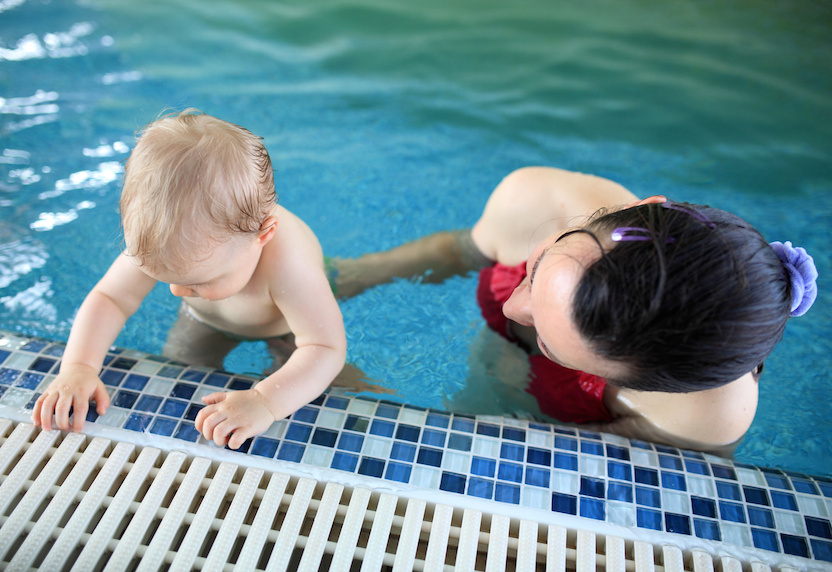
[337, 167, 817, 455]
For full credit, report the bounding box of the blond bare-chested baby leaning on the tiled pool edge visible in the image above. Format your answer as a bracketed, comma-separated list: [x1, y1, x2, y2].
[33, 110, 346, 449]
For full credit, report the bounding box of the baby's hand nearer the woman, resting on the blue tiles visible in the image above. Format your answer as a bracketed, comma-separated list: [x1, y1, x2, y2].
[196, 389, 275, 449]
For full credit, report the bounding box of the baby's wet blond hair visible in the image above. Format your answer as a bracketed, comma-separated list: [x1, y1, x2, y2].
[119, 109, 276, 270]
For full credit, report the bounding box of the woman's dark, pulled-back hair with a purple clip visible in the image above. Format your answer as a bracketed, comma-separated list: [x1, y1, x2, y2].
[572, 203, 791, 393]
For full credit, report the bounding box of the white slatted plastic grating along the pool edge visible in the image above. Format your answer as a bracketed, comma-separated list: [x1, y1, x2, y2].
[0, 419, 808, 572]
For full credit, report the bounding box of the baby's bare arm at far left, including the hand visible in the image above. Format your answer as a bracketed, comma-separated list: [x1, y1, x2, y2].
[32, 255, 155, 431]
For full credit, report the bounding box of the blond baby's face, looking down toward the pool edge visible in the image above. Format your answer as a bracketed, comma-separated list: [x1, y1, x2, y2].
[142, 237, 262, 301]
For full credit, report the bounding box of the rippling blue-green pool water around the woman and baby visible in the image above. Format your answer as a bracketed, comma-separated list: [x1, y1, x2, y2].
[0, 0, 832, 475]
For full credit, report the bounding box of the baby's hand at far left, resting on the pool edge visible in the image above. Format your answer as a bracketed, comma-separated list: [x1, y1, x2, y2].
[32, 364, 110, 431]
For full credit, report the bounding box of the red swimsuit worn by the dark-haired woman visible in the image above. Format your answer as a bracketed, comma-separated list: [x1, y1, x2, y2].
[477, 262, 612, 423]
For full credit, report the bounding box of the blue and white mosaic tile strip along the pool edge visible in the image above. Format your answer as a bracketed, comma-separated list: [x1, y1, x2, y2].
[0, 331, 832, 567]
